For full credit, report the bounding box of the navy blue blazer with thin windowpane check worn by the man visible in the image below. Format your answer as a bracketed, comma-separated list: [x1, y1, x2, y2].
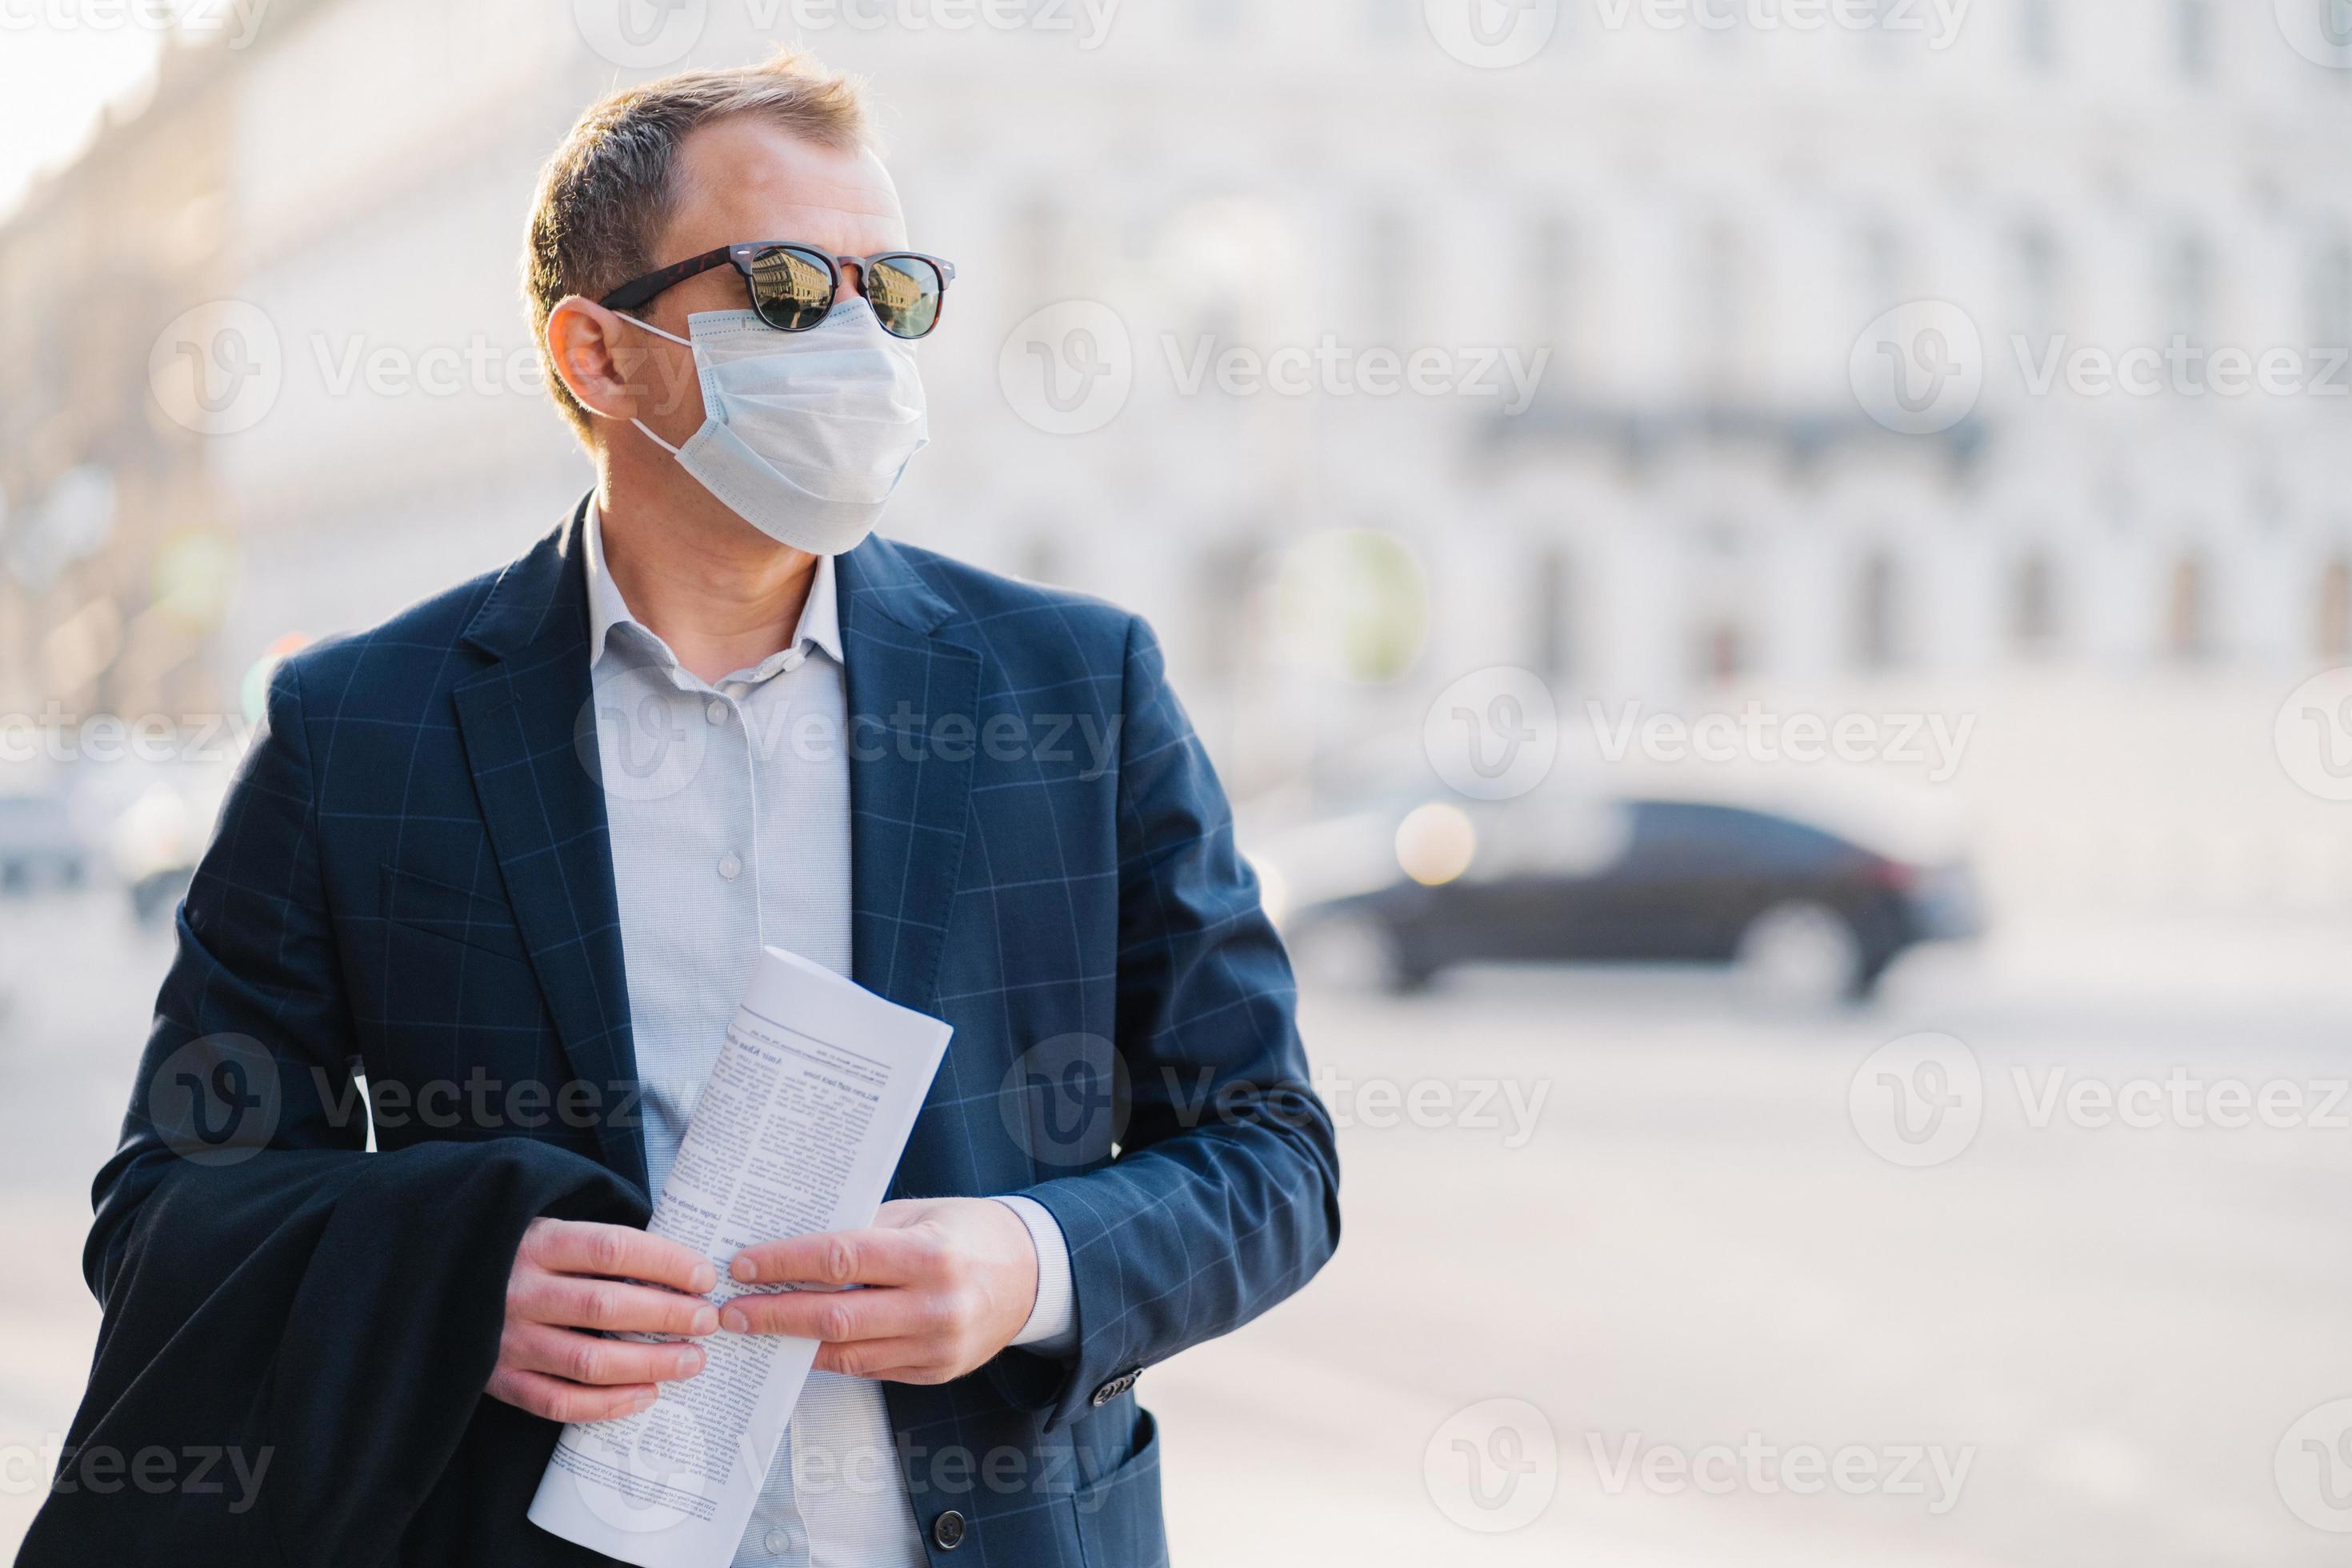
[87, 510, 1338, 1568]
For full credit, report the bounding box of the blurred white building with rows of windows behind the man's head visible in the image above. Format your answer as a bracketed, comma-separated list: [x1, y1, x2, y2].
[14, 0, 2352, 907]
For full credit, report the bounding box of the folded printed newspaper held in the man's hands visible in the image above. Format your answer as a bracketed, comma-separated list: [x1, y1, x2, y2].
[530, 947, 948, 1568]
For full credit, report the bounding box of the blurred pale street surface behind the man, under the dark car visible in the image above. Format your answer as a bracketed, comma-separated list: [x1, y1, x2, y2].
[0, 889, 2352, 1568]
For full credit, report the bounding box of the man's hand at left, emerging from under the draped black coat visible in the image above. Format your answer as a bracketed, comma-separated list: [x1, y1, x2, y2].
[490, 1218, 714, 1422]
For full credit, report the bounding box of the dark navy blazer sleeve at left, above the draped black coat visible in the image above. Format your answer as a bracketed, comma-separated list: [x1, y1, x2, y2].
[82, 661, 367, 1305]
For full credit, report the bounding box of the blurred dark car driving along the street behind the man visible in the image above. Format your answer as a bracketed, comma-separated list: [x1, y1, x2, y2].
[1286, 799, 1978, 1002]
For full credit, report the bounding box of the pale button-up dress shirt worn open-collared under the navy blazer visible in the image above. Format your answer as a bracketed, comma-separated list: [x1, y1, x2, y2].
[586, 503, 1075, 1568]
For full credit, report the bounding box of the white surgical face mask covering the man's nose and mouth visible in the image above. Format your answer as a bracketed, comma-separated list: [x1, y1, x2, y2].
[626, 296, 931, 554]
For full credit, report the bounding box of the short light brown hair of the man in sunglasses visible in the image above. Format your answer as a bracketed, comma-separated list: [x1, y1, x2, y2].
[522, 50, 873, 440]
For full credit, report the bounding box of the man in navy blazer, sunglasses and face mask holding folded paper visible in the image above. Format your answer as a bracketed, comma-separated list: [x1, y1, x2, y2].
[28, 57, 1338, 1568]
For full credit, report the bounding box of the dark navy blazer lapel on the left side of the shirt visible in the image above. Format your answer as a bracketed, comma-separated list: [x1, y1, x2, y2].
[454, 501, 647, 1187]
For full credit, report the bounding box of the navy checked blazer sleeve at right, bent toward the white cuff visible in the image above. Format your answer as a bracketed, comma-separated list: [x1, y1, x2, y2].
[1000, 621, 1338, 1427]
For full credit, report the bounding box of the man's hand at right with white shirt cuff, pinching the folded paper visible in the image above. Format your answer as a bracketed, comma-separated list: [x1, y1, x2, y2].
[725, 1199, 1038, 1382]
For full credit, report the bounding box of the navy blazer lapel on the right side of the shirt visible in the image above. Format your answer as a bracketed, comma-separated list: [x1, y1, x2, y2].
[835, 538, 981, 1014]
